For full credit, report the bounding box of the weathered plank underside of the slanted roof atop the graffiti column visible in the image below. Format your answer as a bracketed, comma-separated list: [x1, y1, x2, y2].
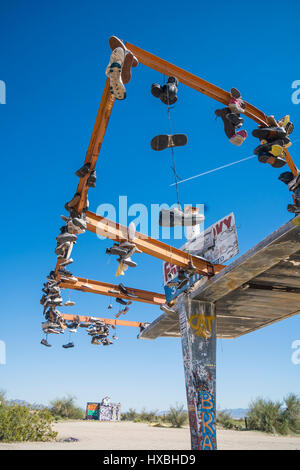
[139, 216, 300, 339]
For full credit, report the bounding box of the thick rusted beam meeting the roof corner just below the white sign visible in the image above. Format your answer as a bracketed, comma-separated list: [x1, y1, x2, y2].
[86, 211, 224, 276]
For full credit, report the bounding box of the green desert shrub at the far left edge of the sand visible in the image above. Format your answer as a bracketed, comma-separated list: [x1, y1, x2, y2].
[0, 404, 57, 442]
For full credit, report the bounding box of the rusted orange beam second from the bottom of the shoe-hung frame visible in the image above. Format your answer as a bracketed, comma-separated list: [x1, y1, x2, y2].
[58, 276, 166, 305]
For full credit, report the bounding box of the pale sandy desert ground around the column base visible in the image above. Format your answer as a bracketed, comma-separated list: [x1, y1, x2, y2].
[0, 421, 300, 450]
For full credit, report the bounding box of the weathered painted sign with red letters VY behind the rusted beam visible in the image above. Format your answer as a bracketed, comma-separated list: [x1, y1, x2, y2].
[163, 212, 239, 302]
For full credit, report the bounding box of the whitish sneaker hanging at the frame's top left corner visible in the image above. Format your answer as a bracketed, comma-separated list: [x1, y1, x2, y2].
[105, 47, 126, 100]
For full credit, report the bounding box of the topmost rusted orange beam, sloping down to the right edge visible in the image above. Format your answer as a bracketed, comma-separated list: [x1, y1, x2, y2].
[126, 42, 298, 176]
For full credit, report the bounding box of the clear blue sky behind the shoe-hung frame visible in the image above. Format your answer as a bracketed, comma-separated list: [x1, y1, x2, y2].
[0, 0, 300, 409]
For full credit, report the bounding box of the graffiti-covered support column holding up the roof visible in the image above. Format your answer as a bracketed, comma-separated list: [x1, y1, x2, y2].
[178, 294, 217, 450]
